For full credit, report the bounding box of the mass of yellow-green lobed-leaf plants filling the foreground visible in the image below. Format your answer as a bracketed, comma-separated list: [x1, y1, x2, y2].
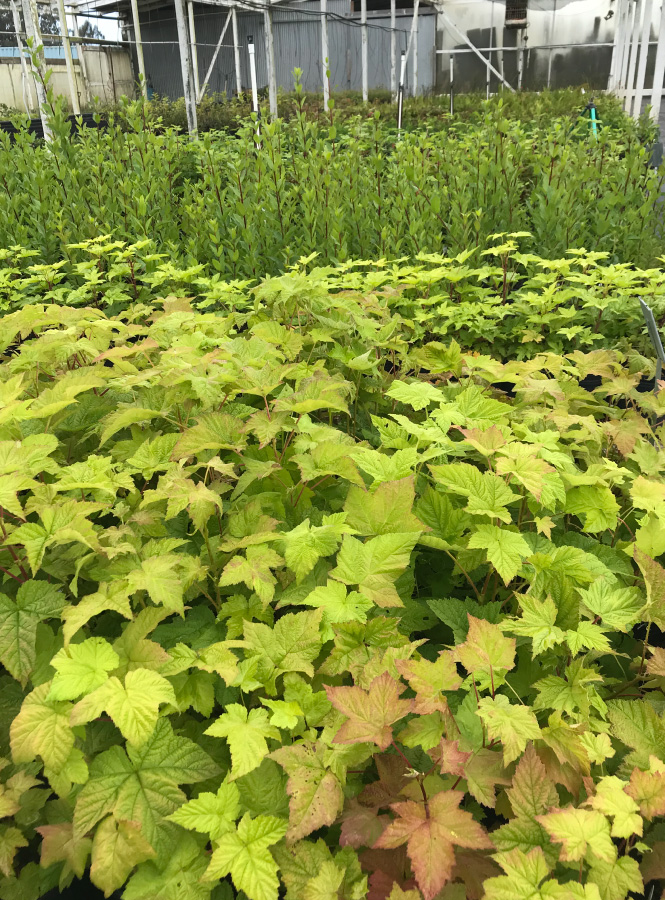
[0, 253, 665, 900]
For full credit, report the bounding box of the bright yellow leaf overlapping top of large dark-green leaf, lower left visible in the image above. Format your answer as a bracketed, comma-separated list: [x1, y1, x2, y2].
[70, 668, 176, 747]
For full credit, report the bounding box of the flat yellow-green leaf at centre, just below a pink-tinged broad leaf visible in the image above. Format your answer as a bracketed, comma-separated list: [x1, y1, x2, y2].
[330, 531, 420, 608]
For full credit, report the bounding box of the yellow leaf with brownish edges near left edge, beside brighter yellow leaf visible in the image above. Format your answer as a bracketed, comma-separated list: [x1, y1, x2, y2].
[9, 682, 74, 771]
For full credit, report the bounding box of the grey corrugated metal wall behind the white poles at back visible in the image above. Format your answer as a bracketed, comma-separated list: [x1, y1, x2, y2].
[135, 0, 436, 99]
